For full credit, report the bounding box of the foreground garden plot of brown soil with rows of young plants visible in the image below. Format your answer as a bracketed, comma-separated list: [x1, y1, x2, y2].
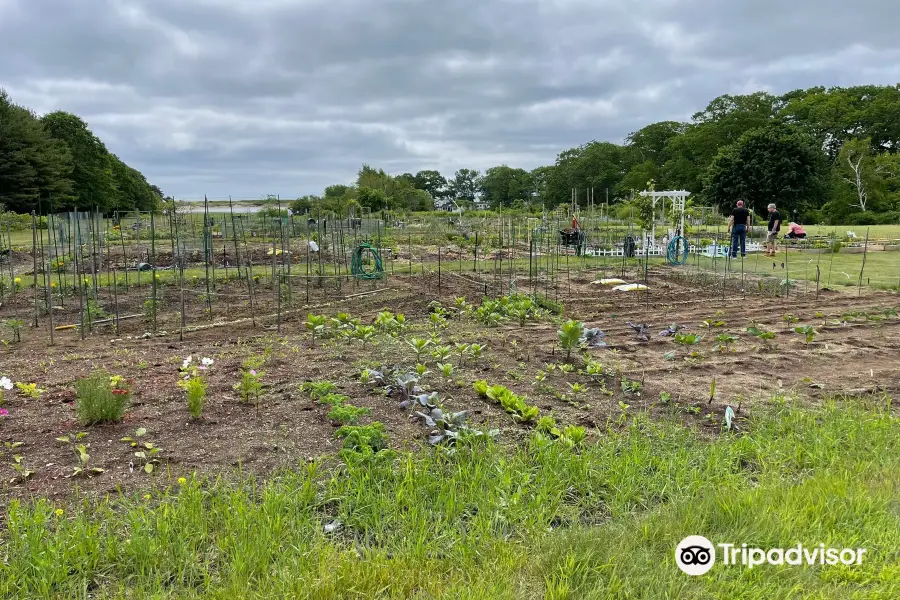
[0, 271, 900, 497]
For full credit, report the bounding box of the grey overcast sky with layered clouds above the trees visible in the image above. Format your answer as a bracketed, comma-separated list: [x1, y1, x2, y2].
[0, 0, 900, 199]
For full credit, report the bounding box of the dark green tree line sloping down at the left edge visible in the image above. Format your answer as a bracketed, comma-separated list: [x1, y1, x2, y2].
[0, 89, 162, 214]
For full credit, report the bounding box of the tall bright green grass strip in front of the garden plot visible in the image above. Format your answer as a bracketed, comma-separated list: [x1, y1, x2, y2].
[0, 401, 900, 599]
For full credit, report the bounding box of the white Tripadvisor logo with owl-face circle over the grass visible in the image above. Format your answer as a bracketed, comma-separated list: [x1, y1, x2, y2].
[675, 535, 866, 575]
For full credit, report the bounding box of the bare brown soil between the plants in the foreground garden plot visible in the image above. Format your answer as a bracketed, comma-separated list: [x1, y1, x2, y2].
[0, 270, 900, 499]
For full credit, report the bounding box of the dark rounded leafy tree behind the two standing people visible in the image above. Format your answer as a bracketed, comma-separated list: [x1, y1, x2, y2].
[705, 125, 828, 220]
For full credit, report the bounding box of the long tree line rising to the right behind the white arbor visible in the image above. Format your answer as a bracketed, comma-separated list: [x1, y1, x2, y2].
[295, 85, 900, 224]
